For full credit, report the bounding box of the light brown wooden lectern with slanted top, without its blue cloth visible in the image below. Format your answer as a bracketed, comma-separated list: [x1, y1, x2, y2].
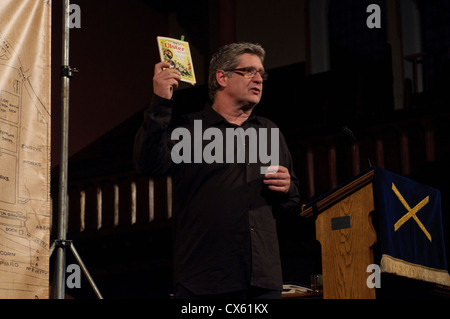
[302, 169, 377, 299]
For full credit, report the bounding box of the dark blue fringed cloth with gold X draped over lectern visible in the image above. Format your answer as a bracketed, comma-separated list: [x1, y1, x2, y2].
[374, 168, 450, 285]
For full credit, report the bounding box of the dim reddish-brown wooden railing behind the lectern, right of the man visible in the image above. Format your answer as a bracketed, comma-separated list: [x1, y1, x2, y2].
[291, 114, 450, 199]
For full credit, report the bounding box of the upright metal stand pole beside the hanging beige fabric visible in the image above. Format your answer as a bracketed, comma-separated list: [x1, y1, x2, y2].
[53, 0, 70, 299]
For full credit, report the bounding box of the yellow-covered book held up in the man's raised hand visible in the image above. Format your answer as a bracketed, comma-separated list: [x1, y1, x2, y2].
[156, 36, 196, 85]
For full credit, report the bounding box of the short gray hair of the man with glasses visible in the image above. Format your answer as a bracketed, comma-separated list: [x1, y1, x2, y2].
[208, 42, 266, 101]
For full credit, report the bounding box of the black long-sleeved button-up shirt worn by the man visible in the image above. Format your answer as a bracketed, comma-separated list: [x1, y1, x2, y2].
[134, 96, 300, 294]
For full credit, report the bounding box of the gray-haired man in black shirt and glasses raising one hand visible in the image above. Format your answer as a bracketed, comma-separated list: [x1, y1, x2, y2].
[135, 43, 300, 298]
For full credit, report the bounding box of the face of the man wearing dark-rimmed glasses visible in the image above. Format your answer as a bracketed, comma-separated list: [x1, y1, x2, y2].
[225, 53, 264, 107]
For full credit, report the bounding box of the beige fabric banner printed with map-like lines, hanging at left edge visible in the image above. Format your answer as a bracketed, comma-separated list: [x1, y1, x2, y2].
[0, 0, 51, 299]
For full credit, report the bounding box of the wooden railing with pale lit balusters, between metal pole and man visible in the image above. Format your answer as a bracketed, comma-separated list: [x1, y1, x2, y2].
[53, 172, 172, 234]
